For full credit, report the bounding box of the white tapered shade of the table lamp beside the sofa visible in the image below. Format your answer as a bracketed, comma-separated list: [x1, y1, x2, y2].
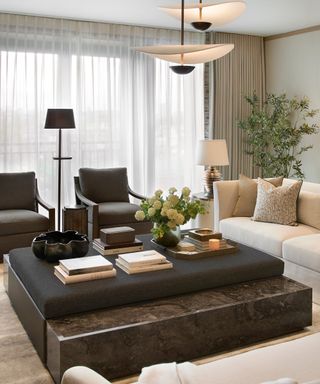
[197, 140, 229, 166]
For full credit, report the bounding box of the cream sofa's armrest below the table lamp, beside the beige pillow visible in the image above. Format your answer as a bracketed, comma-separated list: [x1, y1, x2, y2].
[213, 180, 239, 231]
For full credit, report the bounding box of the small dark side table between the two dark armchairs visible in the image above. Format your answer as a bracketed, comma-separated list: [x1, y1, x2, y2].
[62, 205, 88, 235]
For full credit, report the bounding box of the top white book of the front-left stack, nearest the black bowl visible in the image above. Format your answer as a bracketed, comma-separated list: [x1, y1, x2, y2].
[59, 255, 113, 275]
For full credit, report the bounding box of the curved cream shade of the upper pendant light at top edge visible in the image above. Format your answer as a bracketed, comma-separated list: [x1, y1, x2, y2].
[159, 1, 246, 27]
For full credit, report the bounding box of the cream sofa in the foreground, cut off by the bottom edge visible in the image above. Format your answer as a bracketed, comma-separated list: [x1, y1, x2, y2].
[61, 333, 320, 384]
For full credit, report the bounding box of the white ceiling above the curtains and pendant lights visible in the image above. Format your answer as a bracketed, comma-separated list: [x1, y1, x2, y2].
[0, 0, 320, 36]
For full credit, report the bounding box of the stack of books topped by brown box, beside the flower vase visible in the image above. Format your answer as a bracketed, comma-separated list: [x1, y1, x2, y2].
[92, 227, 143, 256]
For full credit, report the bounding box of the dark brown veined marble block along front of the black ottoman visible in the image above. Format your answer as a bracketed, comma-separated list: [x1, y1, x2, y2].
[46, 277, 312, 383]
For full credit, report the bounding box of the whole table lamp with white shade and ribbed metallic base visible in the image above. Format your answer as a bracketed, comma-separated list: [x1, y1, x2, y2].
[197, 139, 229, 198]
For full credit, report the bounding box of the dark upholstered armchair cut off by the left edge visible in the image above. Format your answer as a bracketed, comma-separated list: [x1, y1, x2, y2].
[0, 172, 55, 260]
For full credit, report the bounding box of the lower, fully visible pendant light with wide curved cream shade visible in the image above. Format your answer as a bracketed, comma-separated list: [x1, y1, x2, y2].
[136, 0, 234, 75]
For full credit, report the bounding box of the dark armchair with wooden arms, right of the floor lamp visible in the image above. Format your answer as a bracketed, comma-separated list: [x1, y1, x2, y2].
[74, 168, 152, 239]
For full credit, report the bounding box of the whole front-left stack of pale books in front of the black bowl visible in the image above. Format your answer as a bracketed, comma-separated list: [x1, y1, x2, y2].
[54, 255, 117, 284]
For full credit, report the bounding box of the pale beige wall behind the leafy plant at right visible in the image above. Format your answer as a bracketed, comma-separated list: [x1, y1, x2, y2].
[265, 31, 320, 182]
